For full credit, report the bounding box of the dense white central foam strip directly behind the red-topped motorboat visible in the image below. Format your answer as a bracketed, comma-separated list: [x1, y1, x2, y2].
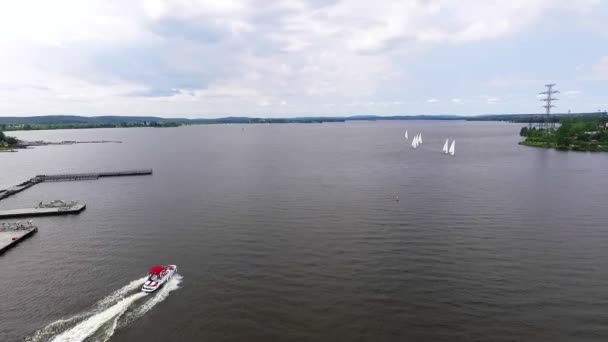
[52, 292, 147, 342]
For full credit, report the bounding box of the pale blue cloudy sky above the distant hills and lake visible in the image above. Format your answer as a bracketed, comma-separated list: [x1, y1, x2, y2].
[0, 0, 608, 118]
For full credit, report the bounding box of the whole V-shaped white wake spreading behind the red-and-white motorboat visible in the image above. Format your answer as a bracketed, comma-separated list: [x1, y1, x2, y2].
[25, 274, 182, 342]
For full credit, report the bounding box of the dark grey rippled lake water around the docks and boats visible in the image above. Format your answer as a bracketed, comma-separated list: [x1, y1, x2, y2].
[0, 121, 608, 341]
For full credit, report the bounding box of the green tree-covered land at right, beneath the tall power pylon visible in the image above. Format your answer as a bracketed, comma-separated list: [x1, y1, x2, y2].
[520, 115, 608, 152]
